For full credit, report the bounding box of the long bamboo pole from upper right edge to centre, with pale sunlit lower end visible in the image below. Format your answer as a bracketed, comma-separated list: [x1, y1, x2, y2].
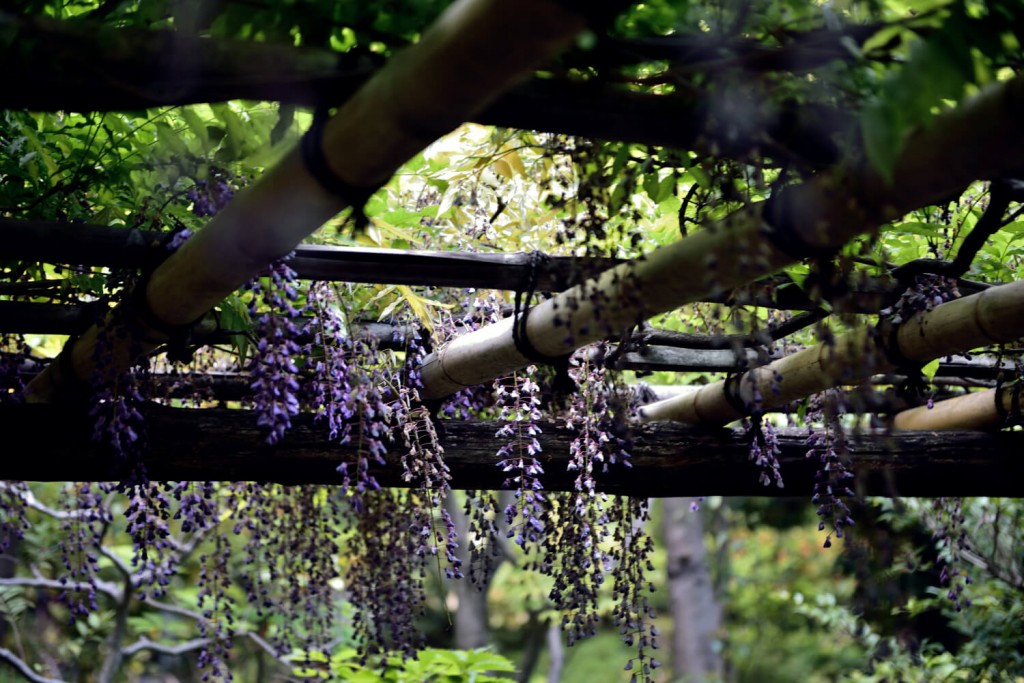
[422, 78, 1024, 397]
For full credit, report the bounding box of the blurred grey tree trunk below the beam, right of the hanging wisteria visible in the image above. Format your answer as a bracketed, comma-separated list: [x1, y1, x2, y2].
[662, 498, 724, 683]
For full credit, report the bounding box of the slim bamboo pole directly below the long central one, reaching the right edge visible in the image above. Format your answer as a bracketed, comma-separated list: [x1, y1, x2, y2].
[640, 281, 1024, 424]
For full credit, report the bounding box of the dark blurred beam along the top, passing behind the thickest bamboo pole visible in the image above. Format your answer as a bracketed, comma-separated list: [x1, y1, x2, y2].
[0, 12, 850, 161]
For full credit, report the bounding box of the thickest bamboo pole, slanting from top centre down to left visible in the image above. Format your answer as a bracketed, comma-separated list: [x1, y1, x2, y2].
[19, 0, 585, 402]
